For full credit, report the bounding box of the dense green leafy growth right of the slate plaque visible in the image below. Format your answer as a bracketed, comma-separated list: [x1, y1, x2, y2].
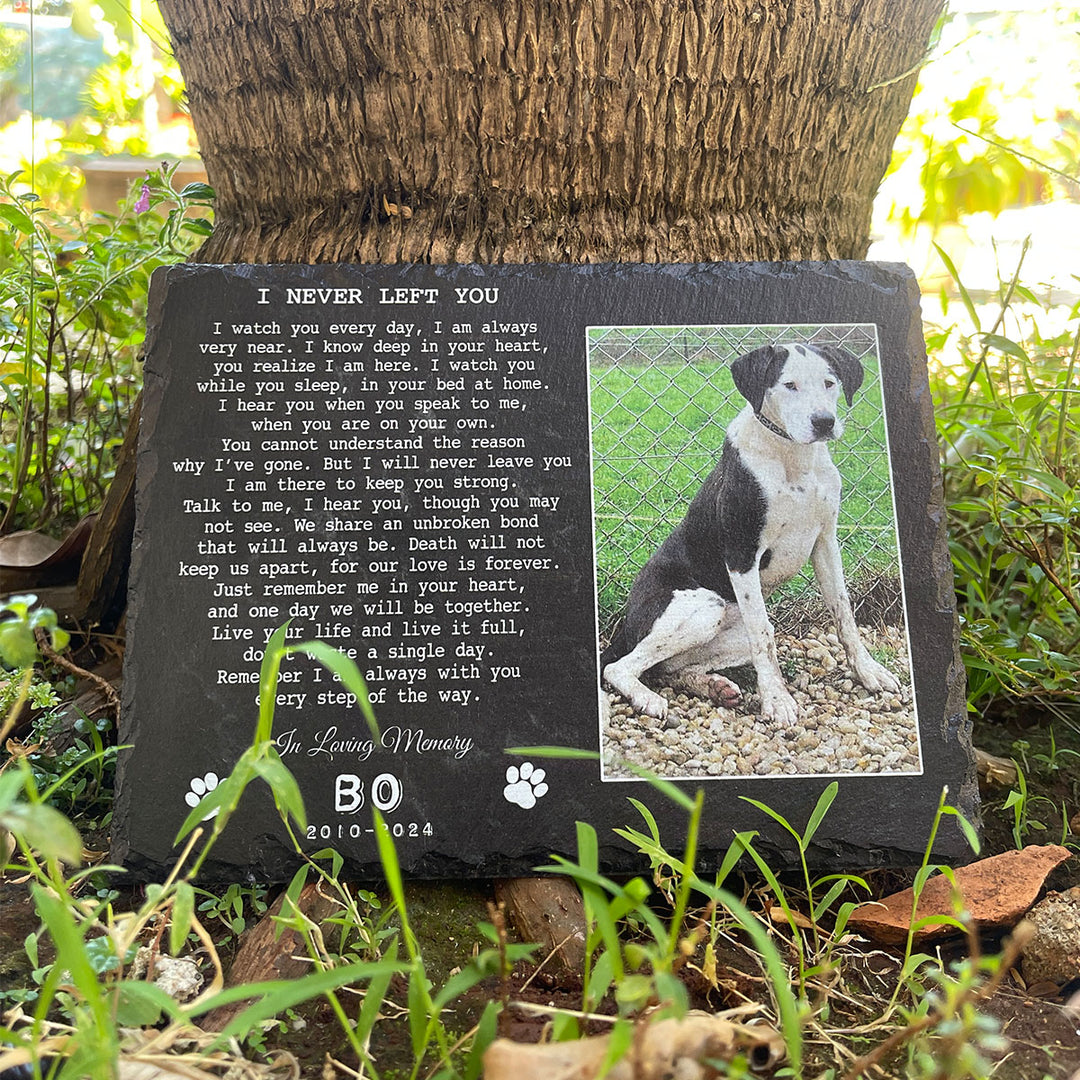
[934, 252, 1080, 712]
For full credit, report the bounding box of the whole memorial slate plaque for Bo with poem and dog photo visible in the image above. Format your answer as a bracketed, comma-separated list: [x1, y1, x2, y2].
[113, 262, 977, 880]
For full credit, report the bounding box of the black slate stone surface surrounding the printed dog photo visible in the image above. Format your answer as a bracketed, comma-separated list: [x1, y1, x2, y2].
[113, 262, 977, 880]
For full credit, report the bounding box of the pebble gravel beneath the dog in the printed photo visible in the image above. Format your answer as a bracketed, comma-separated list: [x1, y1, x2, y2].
[603, 626, 920, 780]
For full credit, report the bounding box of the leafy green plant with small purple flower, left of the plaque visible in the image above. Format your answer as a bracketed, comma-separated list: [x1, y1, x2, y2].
[0, 165, 213, 535]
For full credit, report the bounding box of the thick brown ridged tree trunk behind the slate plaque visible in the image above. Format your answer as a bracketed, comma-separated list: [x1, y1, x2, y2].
[161, 0, 942, 262]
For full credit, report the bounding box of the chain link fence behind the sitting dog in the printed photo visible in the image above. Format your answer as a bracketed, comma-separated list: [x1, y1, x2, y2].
[588, 324, 903, 639]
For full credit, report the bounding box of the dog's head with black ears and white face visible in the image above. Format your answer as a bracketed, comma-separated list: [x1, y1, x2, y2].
[731, 345, 863, 443]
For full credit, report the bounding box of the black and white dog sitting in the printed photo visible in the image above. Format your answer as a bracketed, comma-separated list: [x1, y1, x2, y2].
[600, 345, 900, 725]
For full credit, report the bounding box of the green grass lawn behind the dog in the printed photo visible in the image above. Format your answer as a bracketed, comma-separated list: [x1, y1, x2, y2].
[591, 330, 897, 630]
